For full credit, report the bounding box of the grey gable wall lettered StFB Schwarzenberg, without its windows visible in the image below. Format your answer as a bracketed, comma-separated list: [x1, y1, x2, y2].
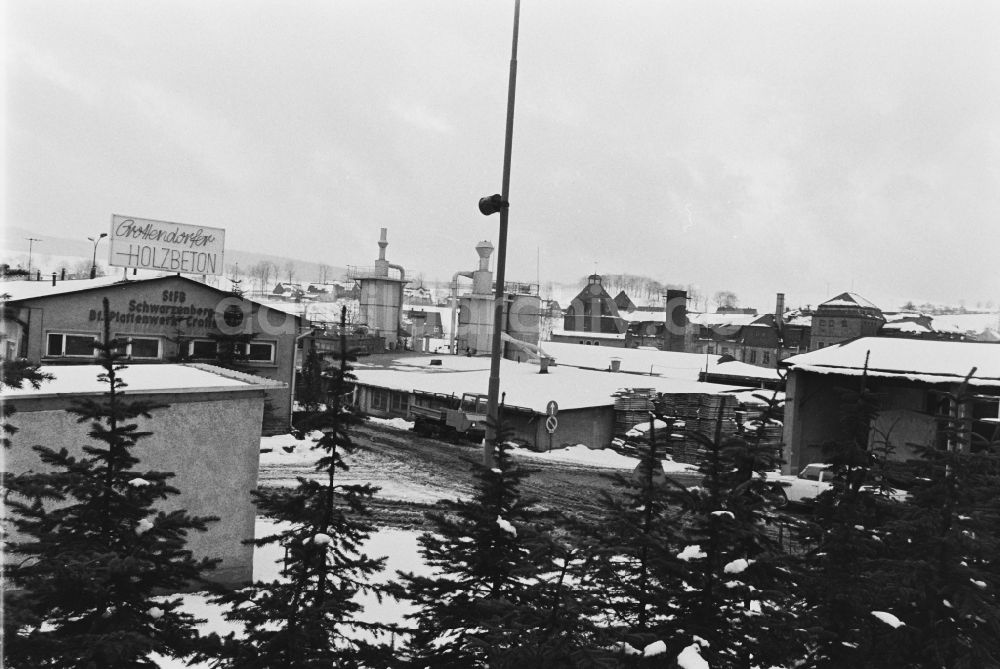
[10, 277, 297, 433]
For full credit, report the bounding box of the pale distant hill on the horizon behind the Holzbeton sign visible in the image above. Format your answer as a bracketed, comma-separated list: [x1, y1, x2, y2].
[0, 226, 347, 283]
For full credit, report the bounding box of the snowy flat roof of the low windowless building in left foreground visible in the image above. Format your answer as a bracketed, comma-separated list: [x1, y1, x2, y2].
[3, 364, 287, 399]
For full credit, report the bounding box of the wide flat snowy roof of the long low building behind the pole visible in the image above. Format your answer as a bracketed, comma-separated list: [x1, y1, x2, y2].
[354, 354, 746, 413]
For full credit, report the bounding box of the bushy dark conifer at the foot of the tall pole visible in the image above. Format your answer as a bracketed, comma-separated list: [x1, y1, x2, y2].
[401, 404, 589, 669]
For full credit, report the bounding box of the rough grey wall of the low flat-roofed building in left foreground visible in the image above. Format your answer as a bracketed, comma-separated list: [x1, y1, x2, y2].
[4, 388, 264, 586]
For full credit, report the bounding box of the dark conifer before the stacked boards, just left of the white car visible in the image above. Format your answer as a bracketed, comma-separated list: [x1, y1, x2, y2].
[656, 402, 792, 669]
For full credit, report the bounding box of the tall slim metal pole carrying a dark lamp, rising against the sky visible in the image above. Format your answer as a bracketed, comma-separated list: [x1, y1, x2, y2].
[483, 0, 521, 467]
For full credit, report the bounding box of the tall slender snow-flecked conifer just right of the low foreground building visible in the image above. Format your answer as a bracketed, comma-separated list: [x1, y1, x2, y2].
[201, 310, 392, 669]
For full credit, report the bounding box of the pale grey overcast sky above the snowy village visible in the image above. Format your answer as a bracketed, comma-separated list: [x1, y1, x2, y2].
[4, 0, 1000, 309]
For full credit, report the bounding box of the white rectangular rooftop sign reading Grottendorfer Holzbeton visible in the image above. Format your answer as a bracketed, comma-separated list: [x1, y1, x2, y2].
[108, 214, 226, 275]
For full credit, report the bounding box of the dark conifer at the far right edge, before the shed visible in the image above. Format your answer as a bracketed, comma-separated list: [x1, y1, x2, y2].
[870, 370, 1000, 669]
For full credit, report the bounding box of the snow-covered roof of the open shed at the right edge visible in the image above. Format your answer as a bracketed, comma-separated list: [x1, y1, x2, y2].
[784, 337, 1000, 386]
